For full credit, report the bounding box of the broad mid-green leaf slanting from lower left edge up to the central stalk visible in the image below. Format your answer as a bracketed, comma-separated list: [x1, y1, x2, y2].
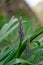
[0, 42, 19, 62]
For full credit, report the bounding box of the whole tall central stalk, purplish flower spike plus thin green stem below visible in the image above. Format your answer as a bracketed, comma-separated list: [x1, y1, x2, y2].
[17, 17, 24, 57]
